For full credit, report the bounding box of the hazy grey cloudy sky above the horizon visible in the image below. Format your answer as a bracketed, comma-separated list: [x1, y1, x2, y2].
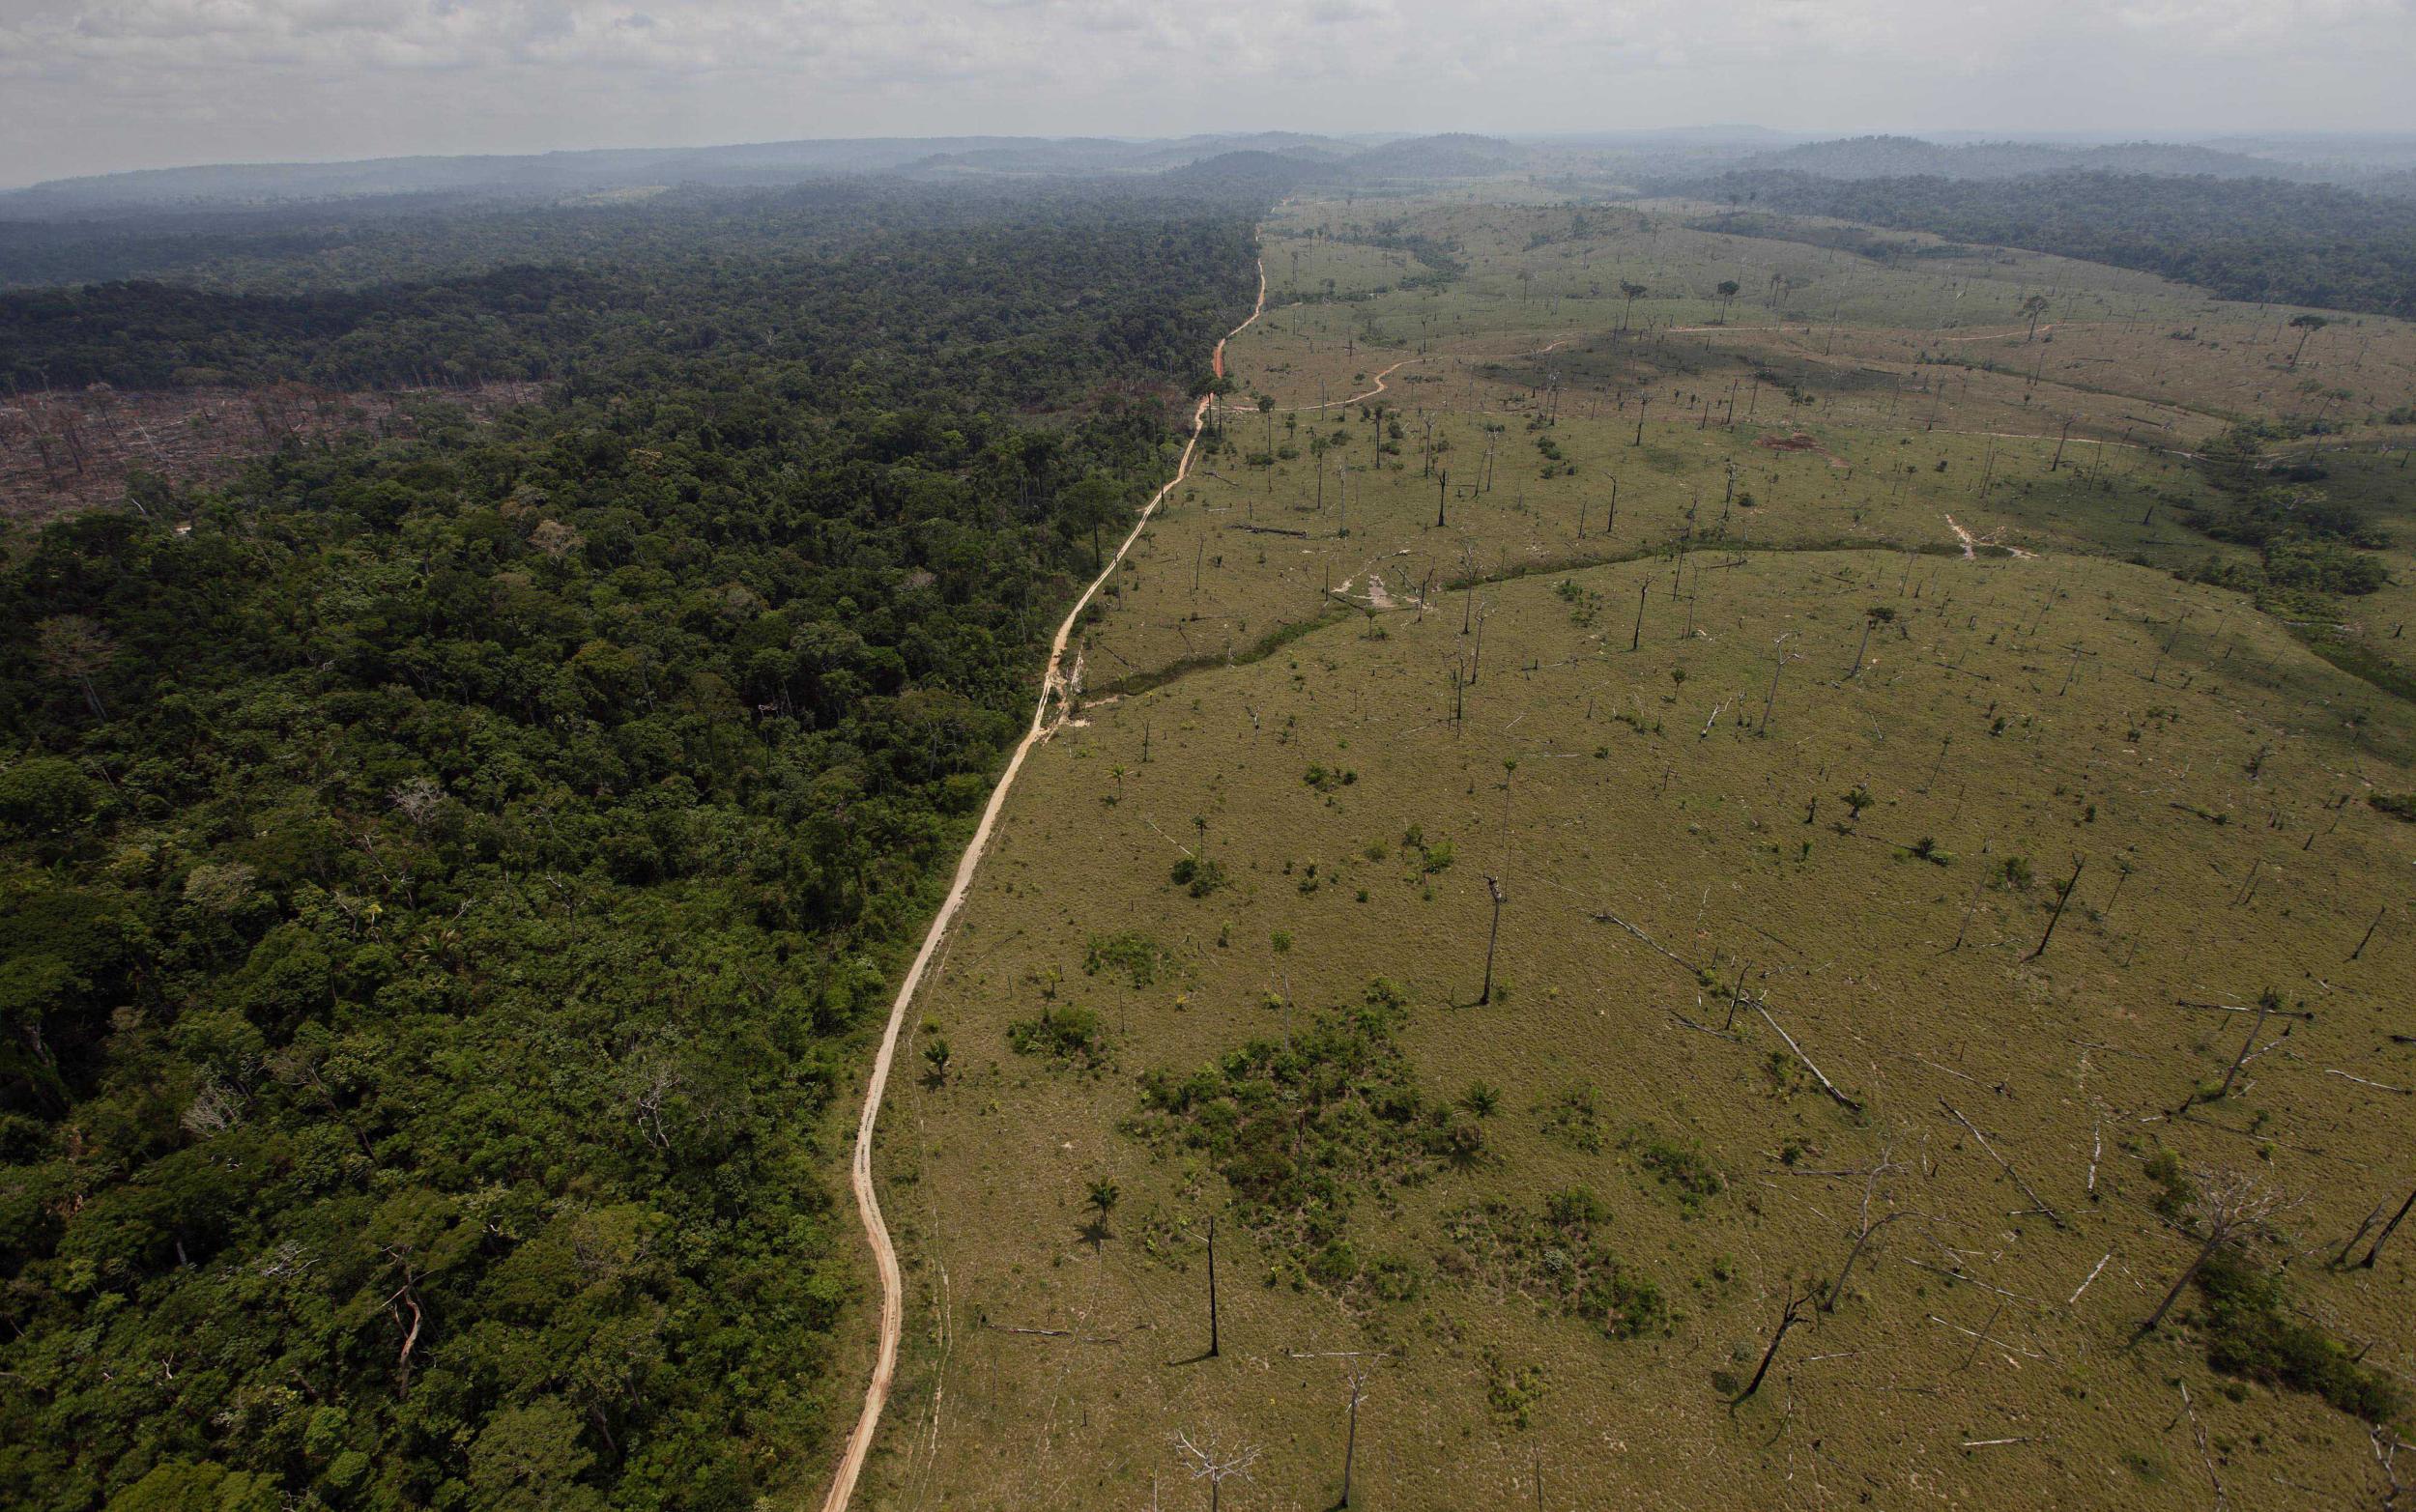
[0, 0, 2416, 184]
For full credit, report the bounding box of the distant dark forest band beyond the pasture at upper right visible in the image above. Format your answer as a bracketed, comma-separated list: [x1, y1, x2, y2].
[1657, 172, 2416, 314]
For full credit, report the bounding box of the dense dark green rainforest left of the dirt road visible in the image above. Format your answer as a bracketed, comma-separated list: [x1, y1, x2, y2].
[0, 186, 1256, 1512]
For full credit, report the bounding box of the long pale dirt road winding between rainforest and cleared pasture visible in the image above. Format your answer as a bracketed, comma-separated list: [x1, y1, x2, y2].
[821, 259, 1266, 1512]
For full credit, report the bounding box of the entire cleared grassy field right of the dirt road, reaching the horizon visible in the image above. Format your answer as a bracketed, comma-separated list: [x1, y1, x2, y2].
[846, 182, 2416, 1507]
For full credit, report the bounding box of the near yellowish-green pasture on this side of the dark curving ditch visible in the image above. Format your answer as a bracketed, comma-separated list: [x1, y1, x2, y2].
[887, 554, 2416, 1507]
